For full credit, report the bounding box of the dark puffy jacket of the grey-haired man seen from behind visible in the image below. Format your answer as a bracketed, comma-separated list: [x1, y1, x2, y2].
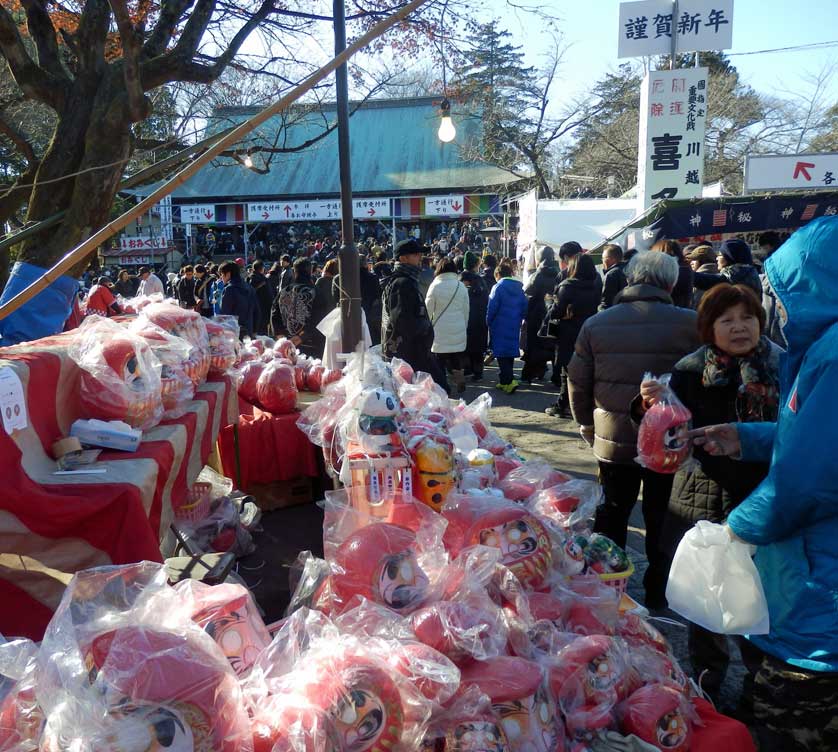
[567, 285, 699, 465]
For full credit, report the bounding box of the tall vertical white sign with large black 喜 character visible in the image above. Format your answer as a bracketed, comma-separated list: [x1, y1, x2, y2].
[637, 68, 708, 212]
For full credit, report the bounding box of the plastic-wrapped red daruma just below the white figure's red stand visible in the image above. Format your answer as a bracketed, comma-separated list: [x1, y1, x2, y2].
[331, 522, 428, 613]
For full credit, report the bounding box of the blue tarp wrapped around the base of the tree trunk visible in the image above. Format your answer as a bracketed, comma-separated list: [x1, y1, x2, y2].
[0, 261, 79, 347]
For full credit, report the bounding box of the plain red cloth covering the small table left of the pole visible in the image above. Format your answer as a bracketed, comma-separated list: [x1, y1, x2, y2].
[218, 401, 319, 493]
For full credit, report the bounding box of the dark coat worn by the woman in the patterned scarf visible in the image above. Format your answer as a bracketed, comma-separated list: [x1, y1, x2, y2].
[648, 345, 781, 556]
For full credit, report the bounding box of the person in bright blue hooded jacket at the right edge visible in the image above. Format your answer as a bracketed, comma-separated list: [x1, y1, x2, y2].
[695, 217, 838, 752]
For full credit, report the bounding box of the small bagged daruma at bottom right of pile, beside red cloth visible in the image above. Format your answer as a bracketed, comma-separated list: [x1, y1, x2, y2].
[619, 684, 691, 752]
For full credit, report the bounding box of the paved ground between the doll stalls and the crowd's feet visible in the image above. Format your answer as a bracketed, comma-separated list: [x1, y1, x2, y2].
[238, 363, 744, 710]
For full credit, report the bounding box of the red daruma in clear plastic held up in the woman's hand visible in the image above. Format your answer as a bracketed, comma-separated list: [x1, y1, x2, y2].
[637, 373, 693, 474]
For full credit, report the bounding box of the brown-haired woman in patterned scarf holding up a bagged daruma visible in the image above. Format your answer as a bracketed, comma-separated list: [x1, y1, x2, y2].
[632, 284, 782, 696]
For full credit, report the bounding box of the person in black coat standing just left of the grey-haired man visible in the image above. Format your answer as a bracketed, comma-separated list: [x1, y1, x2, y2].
[545, 253, 602, 418]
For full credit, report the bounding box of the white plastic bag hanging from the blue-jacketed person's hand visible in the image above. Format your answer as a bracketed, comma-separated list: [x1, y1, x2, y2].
[666, 520, 768, 635]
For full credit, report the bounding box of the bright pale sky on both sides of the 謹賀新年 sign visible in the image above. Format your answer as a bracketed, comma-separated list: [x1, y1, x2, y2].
[485, 0, 838, 106]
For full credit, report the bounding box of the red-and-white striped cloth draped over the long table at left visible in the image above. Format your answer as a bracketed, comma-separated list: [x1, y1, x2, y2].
[0, 334, 238, 640]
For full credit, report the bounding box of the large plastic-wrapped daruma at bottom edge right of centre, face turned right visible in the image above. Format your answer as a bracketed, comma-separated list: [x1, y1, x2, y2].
[461, 657, 564, 752]
